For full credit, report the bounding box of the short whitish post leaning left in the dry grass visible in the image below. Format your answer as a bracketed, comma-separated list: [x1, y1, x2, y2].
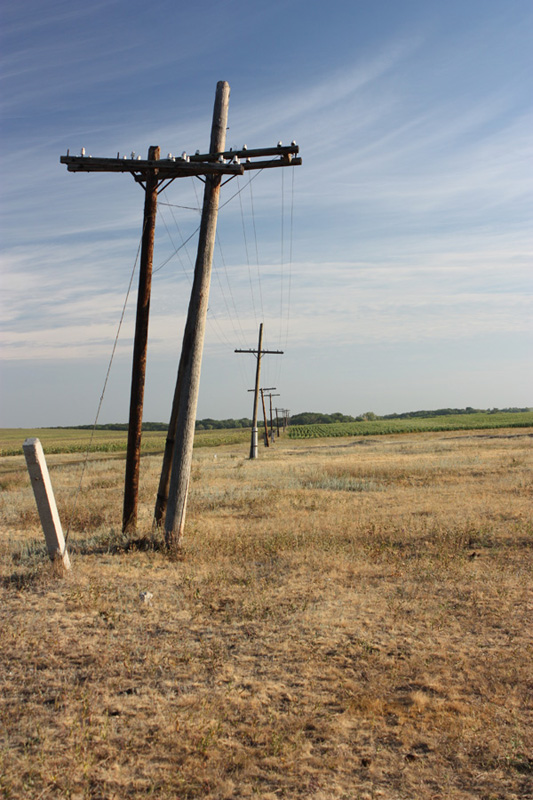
[22, 439, 70, 569]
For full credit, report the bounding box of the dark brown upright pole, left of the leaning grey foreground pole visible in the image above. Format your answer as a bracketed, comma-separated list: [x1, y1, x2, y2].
[122, 147, 160, 533]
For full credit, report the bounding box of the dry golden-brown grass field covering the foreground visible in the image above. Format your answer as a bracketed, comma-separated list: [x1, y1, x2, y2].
[0, 429, 533, 800]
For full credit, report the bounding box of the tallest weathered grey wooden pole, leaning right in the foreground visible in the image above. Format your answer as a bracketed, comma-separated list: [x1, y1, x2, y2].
[165, 81, 230, 550]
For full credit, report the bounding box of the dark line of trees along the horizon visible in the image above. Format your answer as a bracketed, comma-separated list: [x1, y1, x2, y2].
[59, 406, 533, 432]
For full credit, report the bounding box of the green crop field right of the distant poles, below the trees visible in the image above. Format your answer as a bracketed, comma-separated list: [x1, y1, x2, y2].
[287, 411, 533, 439]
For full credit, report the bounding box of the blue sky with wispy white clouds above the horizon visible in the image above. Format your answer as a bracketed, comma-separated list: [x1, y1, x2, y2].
[0, 0, 533, 427]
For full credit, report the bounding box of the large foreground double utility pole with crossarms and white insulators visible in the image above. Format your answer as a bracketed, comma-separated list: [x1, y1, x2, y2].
[60, 81, 302, 543]
